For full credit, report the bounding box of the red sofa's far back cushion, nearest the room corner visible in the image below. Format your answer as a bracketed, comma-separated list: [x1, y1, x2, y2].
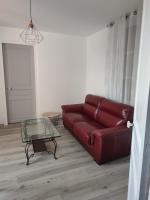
[83, 94, 103, 120]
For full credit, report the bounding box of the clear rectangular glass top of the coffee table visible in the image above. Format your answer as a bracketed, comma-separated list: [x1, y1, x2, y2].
[21, 118, 60, 142]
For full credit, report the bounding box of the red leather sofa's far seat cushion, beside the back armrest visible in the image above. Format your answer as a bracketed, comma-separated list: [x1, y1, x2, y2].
[63, 113, 89, 130]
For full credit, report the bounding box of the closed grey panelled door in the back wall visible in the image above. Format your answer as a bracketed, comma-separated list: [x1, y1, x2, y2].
[3, 44, 35, 123]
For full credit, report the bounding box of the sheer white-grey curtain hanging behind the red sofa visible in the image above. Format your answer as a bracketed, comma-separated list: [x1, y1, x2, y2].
[106, 12, 141, 105]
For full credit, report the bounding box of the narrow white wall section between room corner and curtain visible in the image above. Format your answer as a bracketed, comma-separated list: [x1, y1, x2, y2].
[86, 28, 108, 96]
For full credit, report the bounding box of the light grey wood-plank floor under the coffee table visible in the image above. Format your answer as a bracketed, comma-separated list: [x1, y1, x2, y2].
[0, 120, 129, 200]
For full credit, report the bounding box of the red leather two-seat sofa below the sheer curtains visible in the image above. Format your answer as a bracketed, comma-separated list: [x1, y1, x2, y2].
[62, 95, 133, 164]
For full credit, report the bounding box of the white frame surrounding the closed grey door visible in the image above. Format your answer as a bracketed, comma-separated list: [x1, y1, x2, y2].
[0, 40, 37, 126]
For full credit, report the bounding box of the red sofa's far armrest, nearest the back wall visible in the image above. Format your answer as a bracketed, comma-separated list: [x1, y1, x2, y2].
[61, 104, 84, 113]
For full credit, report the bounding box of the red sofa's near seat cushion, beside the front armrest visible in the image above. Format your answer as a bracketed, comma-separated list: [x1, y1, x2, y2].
[73, 121, 104, 145]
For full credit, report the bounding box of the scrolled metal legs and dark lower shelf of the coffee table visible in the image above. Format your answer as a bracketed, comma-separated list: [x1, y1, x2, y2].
[25, 138, 57, 165]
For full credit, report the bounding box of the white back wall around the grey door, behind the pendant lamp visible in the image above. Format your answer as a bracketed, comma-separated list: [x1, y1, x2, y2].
[0, 27, 86, 123]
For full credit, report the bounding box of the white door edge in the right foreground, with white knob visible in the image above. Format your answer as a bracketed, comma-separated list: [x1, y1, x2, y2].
[128, 0, 150, 200]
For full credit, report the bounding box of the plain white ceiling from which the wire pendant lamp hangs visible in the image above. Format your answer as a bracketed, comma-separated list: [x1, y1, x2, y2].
[0, 0, 139, 36]
